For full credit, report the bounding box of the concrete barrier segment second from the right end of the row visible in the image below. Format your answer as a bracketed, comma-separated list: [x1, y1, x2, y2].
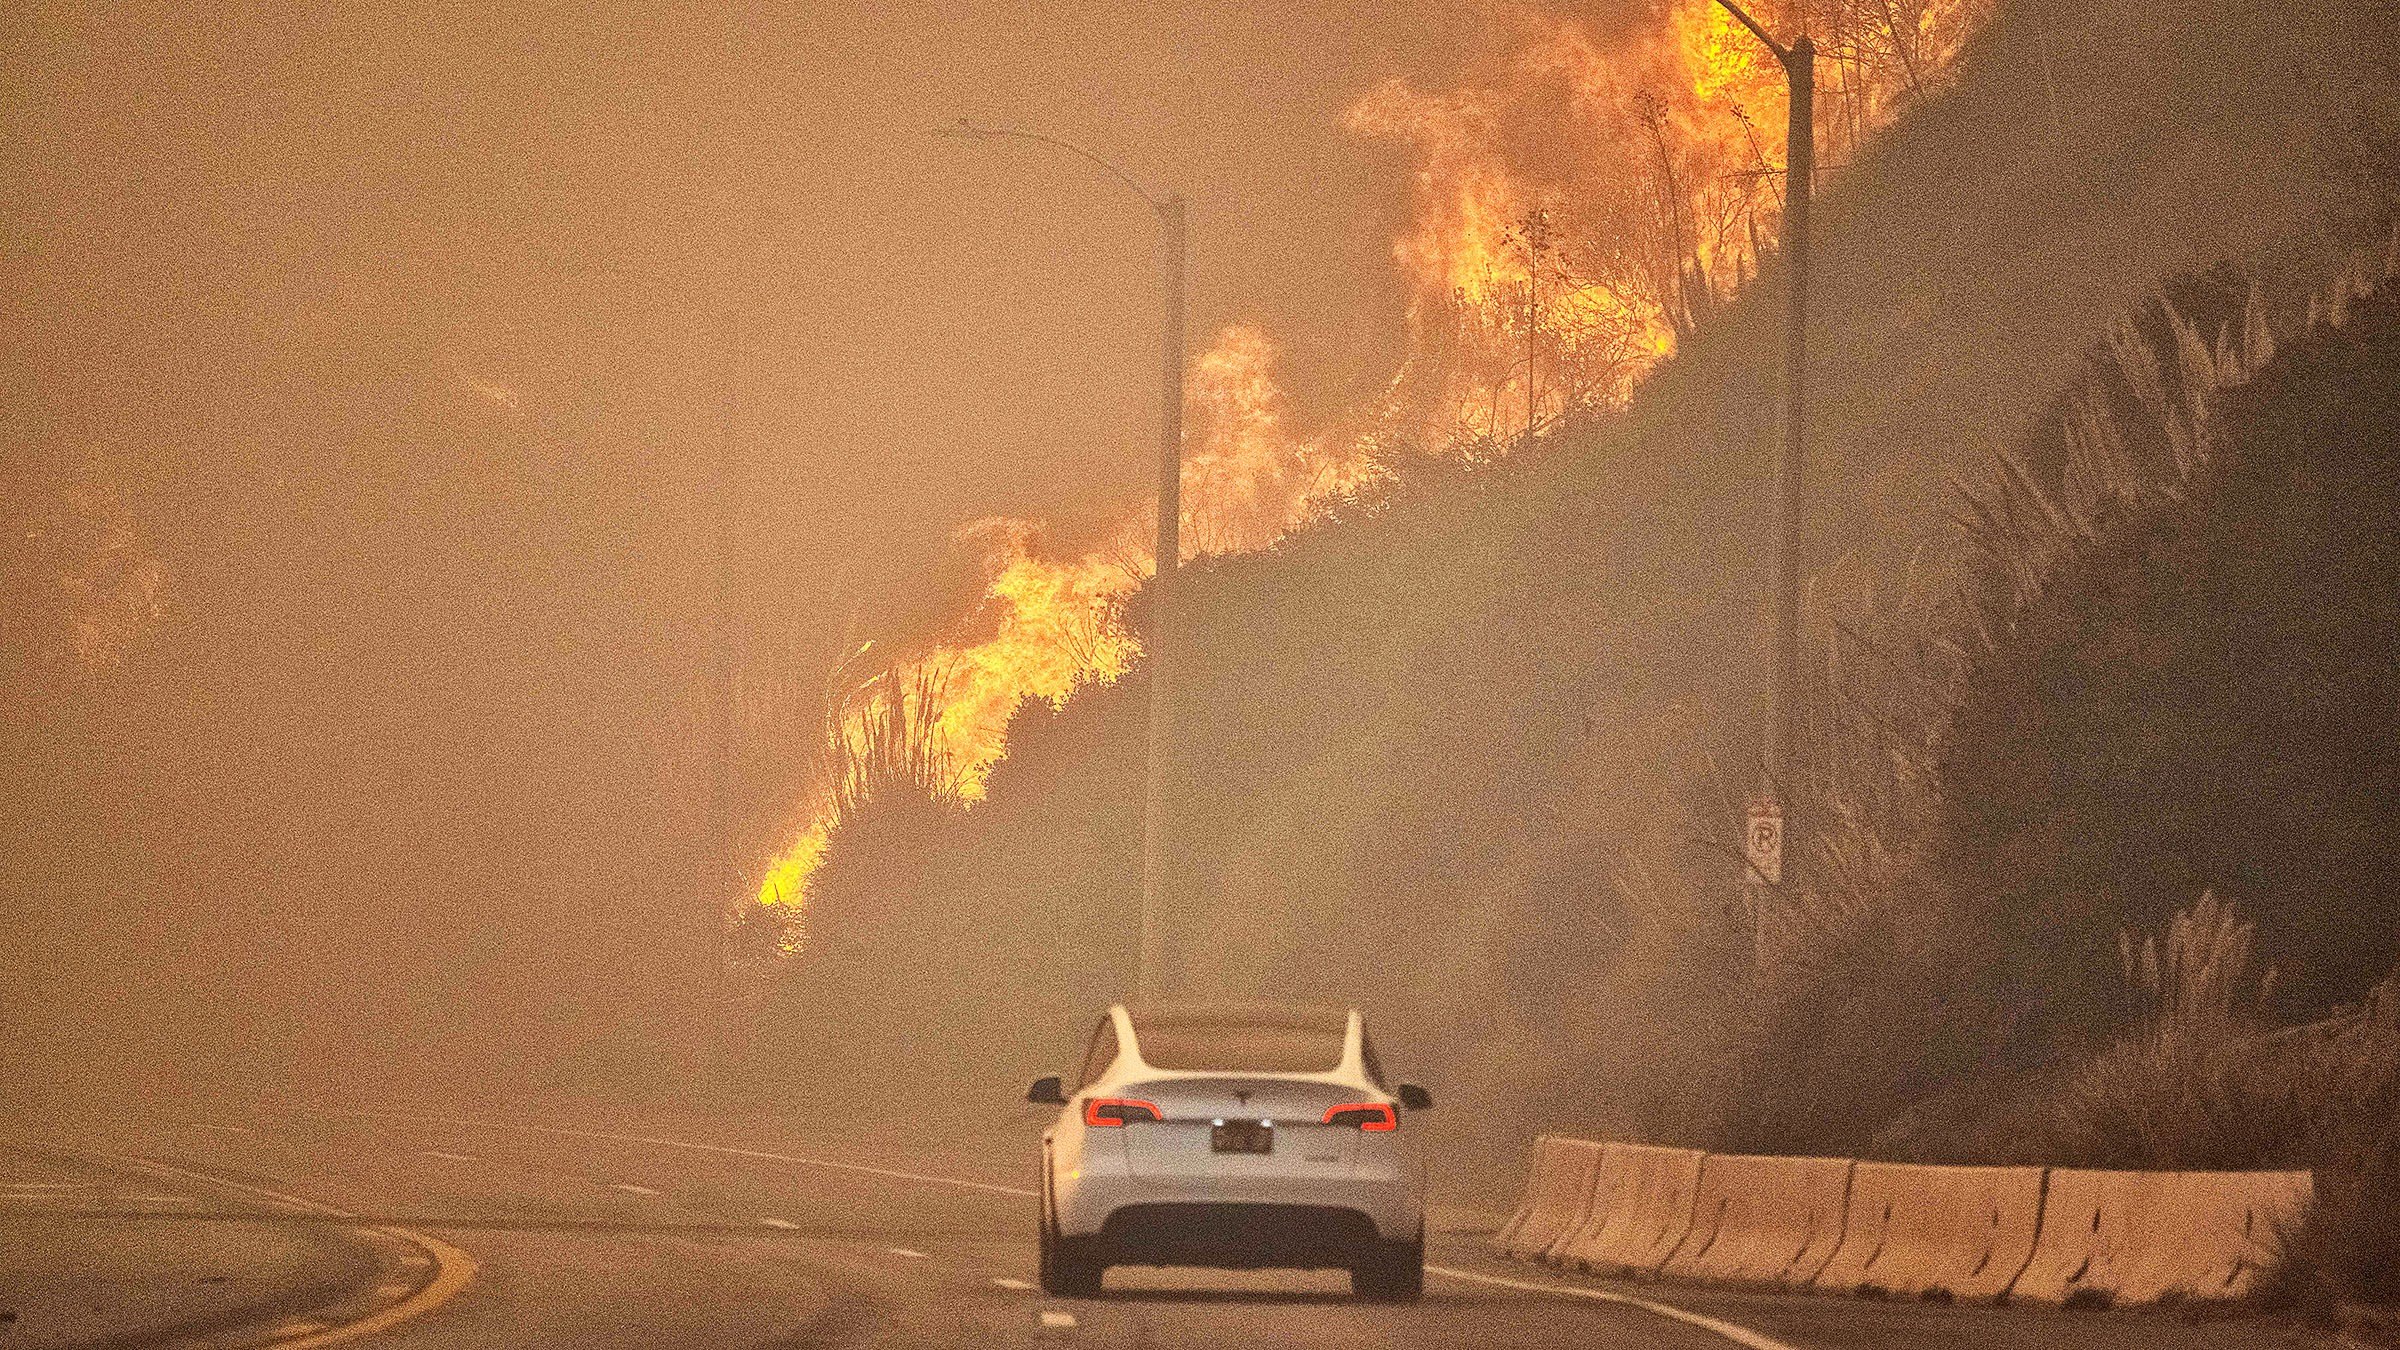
[1812, 1163, 2042, 1300]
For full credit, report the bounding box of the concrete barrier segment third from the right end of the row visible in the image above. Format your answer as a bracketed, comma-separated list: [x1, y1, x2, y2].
[1661, 1153, 1853, 1285]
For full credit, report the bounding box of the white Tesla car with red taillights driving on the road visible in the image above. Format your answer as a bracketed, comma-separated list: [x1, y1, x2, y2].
[1025, 1004, 1433, 1300]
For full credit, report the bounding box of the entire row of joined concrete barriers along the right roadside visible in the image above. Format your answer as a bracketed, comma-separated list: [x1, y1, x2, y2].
[1493, 1136, 2314, 1304]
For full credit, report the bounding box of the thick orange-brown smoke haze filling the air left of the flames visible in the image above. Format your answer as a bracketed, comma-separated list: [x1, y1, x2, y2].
[0, 2, 1555, 1095]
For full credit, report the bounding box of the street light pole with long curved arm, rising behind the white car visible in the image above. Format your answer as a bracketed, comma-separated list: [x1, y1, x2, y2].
[938, 118, 1190, 1002]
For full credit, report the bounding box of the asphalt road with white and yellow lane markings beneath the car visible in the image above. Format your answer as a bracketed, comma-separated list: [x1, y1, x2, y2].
[0, 1105, 2323, 1350]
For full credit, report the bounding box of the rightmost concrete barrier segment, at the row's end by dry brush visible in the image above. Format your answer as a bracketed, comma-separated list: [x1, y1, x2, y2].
[2011, 1167, 2316, 1304]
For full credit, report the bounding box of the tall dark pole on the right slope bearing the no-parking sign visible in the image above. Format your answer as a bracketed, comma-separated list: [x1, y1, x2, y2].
[1716, 0, 1817, 886]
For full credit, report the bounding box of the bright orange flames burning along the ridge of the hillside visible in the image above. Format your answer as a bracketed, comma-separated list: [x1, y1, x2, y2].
[758, 0, 1990, 910]
